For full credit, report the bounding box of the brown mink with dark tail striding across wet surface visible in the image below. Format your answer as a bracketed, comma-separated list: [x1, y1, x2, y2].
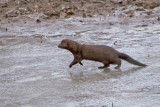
[58, 39, 146, 69]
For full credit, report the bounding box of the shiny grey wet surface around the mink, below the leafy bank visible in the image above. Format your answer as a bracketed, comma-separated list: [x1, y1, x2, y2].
[0, 18, 160, 107]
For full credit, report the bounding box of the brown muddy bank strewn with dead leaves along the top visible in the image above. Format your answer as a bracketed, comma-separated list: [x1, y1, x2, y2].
[0, 0, 160, 22]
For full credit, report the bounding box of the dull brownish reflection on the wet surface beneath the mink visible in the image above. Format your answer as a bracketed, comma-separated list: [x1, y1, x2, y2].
[69, 67, 144, 82]
